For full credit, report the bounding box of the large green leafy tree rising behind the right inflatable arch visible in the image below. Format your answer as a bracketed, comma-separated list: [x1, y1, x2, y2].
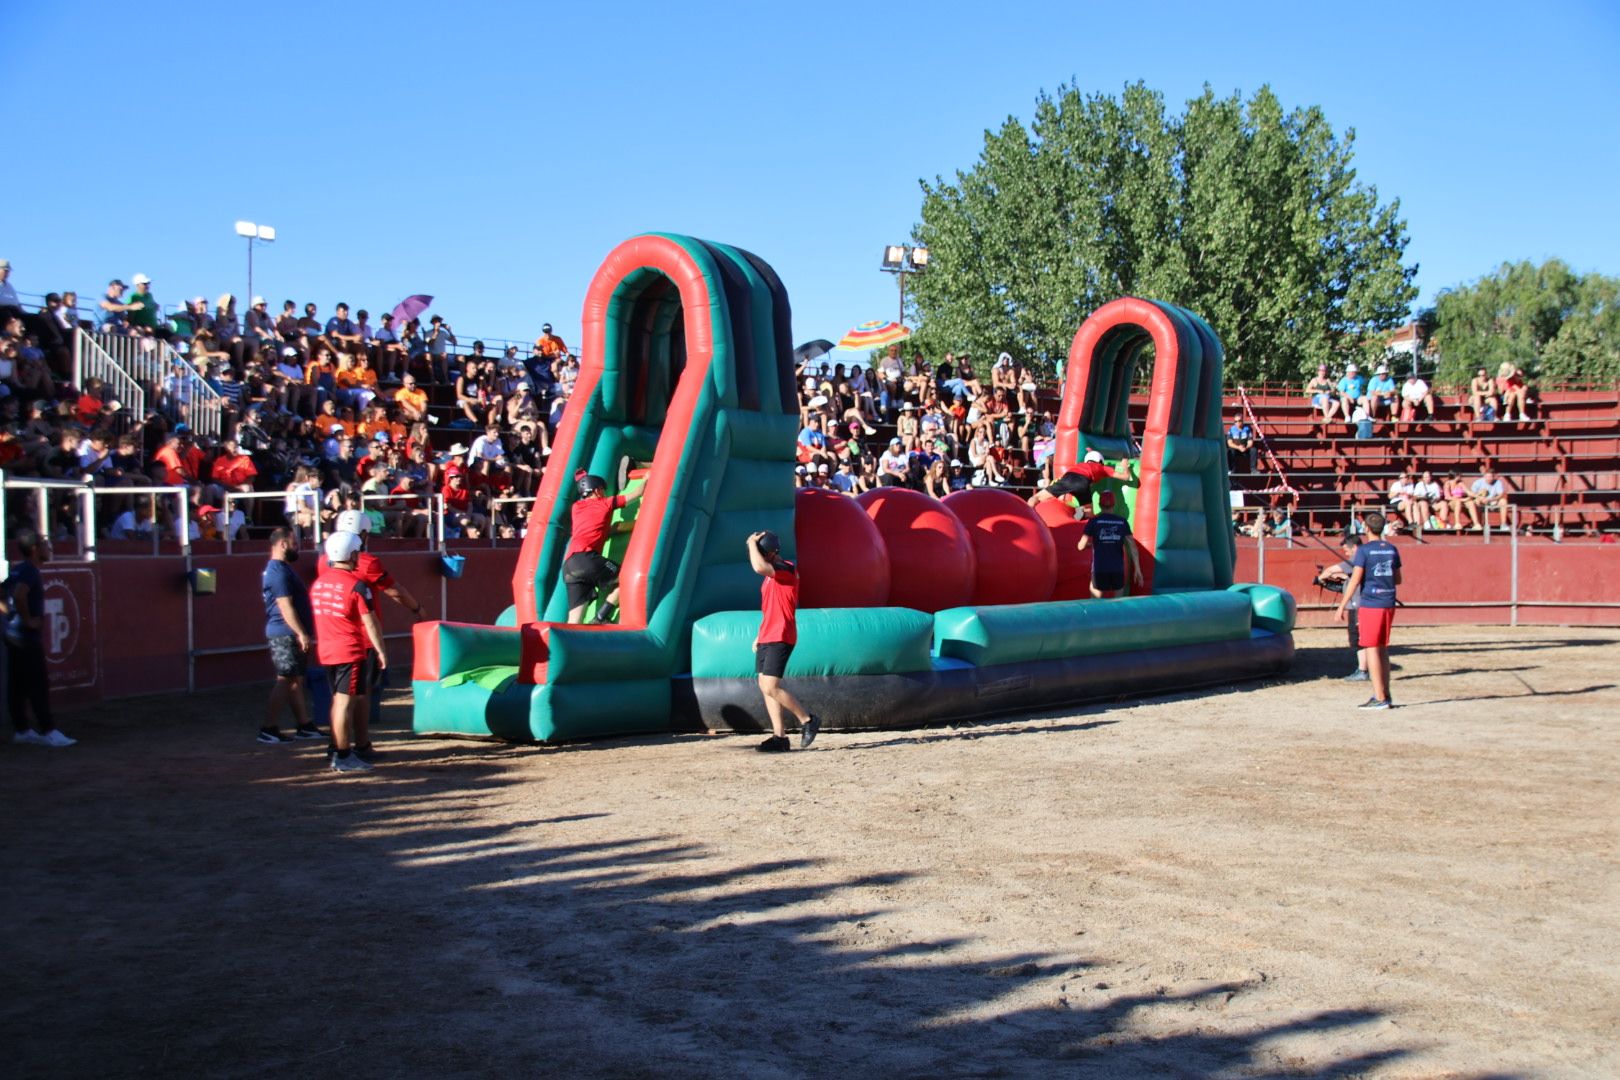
[909, 83, 1416, 381]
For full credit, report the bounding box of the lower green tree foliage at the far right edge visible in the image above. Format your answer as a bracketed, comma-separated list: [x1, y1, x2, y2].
[1426, 259, 1620, 384]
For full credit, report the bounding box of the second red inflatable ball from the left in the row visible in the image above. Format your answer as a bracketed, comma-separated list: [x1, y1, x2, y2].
[855, 487, 975, 612]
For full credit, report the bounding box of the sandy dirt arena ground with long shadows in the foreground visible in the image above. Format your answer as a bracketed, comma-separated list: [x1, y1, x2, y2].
[0, 628, 1620, 1078]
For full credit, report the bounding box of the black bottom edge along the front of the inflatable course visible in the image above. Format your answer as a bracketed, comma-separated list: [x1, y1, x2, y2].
[671, 633, 1294, 732]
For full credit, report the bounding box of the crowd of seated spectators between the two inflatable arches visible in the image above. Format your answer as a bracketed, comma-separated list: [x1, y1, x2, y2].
[795, 345, 1056, 499]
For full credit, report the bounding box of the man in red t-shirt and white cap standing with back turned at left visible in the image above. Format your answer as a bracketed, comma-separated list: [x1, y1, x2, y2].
[309, 533, 389, 772]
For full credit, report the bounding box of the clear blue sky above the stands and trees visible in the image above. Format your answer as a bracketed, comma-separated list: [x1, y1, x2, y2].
[0, 0, 1620, 351]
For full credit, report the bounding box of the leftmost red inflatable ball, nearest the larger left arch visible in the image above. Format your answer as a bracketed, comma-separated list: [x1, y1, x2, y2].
[794, 487, 889, 607]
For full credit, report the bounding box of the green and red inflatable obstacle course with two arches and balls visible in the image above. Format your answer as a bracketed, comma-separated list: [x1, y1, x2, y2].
[415, 233, 1293, 742]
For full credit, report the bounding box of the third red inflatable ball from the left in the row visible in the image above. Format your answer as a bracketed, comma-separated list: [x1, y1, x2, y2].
[944, 487, 1058, 604]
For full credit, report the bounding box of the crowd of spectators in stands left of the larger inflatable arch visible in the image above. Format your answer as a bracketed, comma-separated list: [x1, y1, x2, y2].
[0, 259, 578, 541]
